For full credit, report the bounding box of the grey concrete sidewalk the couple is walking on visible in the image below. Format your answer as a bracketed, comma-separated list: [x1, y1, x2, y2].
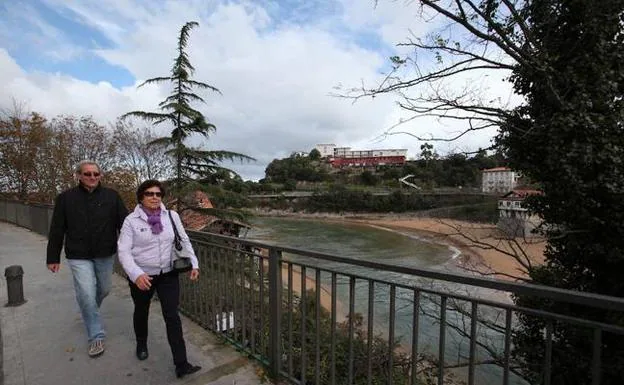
[0, 222, 260, 385]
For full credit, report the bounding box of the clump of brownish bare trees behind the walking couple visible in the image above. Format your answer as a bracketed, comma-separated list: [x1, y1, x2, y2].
[0, 103, 173, 203]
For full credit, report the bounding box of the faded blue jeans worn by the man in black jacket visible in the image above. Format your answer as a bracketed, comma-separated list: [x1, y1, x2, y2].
[67, 256, 113, 342]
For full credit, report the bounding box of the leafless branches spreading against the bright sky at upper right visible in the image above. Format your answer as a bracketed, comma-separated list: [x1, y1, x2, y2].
[336, 0, 540, 141]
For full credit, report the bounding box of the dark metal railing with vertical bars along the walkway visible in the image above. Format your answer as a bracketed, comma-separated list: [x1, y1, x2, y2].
[0, 201, 624, 385]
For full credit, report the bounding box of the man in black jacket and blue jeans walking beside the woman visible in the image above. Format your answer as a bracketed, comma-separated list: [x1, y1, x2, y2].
[46, 160, 128, 357]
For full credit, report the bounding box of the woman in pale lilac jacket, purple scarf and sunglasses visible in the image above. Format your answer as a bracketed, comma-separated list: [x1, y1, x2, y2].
[118, 180, 201, 378]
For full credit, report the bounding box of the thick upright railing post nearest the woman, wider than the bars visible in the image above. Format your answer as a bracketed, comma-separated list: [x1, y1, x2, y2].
[269, 248, 282, 380]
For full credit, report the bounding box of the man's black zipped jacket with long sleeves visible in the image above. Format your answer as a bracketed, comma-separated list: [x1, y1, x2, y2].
[47, 185, 128, 264]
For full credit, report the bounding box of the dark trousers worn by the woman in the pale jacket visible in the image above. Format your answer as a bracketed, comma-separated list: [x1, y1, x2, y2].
[128, 273, 187, 366]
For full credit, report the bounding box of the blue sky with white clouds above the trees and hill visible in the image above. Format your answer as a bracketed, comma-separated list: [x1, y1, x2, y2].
[0, 0, 510, 180]
